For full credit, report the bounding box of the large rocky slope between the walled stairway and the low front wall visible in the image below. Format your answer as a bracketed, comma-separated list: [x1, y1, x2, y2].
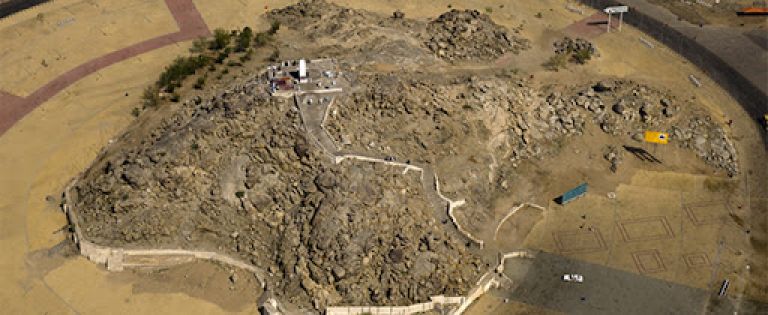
[72, 81, 480, 309]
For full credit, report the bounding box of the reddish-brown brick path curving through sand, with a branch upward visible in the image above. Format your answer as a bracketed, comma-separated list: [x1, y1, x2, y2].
[0, 0, 210, 135]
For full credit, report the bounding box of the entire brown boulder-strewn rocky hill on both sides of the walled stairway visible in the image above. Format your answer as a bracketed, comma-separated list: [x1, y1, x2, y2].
[66, 0, 739, 310]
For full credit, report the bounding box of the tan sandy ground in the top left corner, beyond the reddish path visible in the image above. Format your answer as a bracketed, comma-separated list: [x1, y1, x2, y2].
[0, 0, 178, 96]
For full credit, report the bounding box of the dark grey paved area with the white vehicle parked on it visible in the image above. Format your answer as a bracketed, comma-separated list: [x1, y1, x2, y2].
[492, 253, 768, 314]
